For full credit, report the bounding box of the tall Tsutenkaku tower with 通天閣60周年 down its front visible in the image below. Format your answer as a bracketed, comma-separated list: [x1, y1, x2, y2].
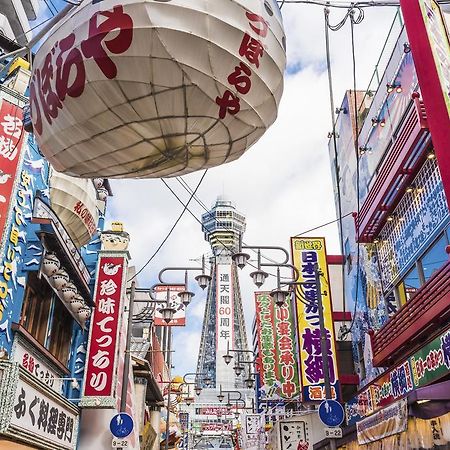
[197, 197, 248, 389]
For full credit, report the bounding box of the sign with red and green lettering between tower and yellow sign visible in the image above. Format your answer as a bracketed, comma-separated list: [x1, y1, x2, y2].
[255, 292, 300, 399]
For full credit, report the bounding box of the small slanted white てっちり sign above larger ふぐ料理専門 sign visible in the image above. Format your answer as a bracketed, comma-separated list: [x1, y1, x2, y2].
[12, 334, 64, 394]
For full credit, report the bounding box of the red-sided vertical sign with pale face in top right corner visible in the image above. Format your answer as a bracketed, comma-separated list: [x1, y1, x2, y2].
[400, 0, 450, 199]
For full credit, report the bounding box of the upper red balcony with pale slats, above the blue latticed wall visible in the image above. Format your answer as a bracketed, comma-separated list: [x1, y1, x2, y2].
[355, 94, 429, 243]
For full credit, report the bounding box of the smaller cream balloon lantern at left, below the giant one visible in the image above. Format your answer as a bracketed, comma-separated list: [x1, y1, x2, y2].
[50, 170, 99, 247]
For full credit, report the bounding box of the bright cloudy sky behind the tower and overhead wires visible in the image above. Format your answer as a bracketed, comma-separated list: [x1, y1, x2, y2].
[34, 2, 396, 375]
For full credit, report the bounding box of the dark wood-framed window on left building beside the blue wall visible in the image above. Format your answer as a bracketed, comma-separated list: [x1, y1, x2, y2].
[20, 272, 73, 365]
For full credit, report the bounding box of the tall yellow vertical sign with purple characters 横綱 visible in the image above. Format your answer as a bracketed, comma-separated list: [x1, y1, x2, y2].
[291, 237, 339, 402]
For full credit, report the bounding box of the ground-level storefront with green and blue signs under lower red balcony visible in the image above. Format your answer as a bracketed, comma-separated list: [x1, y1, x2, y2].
[340, 330, 450, 450]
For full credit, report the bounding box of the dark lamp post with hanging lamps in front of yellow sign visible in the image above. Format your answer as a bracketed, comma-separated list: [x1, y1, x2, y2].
[232, 242, 336, 450]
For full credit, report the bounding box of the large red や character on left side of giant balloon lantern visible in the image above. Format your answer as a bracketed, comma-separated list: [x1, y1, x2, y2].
[81, 5, 133, 80]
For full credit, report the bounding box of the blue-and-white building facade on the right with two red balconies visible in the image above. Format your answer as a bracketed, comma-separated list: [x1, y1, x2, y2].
[329, 1, 450, 448]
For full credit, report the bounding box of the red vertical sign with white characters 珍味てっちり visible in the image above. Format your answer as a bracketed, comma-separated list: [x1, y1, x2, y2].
[82, 254, 127, 406]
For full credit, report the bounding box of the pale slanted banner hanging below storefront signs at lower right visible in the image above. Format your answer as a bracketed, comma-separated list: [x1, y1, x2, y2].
[356, 399, 408, 445]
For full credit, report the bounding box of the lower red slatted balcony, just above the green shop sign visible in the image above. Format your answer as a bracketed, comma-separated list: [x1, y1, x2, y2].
[372, 261, 450, 367]
